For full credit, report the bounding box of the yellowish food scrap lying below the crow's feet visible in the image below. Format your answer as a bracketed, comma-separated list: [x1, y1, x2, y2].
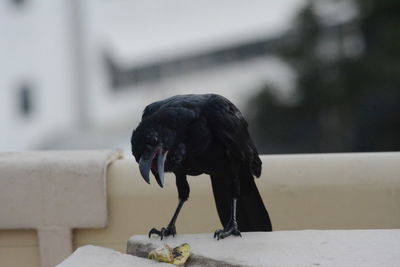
[148, 243, 190, 266]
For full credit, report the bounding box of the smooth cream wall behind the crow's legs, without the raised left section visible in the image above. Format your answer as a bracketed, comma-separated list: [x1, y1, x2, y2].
[0, 153, 400, 267]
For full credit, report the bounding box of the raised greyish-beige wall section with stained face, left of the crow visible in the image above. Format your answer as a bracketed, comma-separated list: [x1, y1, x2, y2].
[0, 150, 122, 267]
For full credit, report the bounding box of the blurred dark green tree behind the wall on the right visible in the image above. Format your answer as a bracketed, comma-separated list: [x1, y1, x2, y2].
[248, 0, 400, 153]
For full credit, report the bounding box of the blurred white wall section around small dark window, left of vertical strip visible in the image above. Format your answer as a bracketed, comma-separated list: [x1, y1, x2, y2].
[0, 0, 75, 150]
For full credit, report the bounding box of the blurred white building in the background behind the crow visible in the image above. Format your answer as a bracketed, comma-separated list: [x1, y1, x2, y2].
[0, 0, 303, 153]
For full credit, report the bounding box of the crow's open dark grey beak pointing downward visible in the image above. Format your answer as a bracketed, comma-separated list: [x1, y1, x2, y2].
[139, 149, 168, 187]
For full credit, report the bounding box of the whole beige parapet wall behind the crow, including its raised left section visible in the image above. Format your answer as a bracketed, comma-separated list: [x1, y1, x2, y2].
[0, 151, 400, 267]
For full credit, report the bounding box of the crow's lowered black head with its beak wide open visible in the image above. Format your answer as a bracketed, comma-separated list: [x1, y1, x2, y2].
[131, 122, 175, 187]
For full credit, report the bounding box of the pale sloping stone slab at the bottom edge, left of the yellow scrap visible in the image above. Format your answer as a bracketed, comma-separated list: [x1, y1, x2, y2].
[57, 245, 172, 267]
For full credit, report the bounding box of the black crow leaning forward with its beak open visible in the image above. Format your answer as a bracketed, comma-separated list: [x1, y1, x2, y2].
[131, 94, 272, 239]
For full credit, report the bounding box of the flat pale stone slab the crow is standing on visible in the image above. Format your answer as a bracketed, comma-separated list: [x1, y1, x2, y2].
[128, 230, 400, 267]
